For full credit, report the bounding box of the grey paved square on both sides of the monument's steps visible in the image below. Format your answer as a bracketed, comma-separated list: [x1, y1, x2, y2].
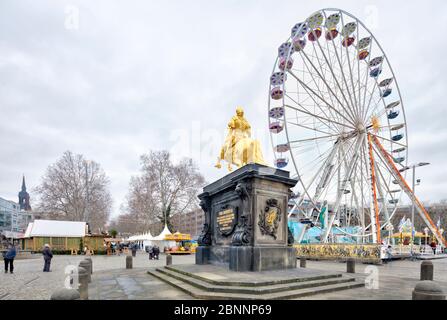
[0, 253, 447, 300]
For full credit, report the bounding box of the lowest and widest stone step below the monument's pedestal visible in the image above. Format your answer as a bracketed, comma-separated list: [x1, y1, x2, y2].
[148, 269, 365, 300]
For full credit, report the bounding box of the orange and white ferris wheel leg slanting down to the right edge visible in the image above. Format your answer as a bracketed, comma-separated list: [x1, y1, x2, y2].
[372, 136, 447, 247]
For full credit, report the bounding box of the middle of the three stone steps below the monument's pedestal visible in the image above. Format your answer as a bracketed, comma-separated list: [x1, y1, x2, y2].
[156, 268, 355, 294]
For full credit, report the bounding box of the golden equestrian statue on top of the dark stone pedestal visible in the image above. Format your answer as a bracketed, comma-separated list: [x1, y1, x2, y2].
[215, 107, 267, 171]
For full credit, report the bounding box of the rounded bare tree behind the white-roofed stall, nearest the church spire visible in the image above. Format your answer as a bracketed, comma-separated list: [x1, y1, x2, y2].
[35, 151, 112, 232]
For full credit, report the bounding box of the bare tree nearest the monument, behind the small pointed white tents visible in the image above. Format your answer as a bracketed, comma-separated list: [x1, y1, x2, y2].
[125, 151, 205, 231]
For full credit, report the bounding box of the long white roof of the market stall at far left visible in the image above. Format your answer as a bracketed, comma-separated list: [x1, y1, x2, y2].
[25, 220, 87, 238]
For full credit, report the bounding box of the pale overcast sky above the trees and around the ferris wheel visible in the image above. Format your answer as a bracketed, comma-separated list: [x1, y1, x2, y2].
[0, 0, 447, 219]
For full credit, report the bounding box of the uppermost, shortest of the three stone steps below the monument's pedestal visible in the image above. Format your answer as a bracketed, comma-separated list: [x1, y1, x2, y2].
[164, 266, 342, 287]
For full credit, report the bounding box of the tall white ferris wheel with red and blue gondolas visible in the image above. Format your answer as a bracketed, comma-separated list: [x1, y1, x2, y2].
[268, 9, 408, 242]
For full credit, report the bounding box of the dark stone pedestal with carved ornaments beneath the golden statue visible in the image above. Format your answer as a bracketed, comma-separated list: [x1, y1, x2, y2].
[196, 164, 297, 271]
